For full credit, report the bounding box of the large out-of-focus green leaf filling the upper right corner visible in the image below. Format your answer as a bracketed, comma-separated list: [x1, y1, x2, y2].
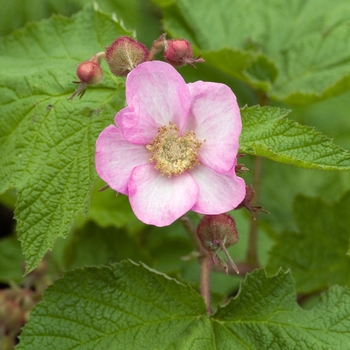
[157, 0, 350, 104]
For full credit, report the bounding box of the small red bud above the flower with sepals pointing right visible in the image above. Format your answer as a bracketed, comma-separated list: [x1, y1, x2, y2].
[164, 39, 204, 67]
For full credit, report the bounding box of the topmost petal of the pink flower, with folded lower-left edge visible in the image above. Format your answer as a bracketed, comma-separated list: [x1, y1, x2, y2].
[118, 61, 191, 144]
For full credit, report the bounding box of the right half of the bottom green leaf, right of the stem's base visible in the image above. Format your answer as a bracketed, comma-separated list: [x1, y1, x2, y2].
[212, 270, 350, 350]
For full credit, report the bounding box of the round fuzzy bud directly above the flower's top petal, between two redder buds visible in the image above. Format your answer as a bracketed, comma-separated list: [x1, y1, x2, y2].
[106, 36, 148, 77]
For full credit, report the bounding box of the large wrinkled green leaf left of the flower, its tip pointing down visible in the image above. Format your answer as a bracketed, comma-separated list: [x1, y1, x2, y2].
[0, 7, 130, 271]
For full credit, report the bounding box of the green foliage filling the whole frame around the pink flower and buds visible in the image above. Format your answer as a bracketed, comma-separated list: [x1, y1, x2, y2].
[0, 0, 350, 349]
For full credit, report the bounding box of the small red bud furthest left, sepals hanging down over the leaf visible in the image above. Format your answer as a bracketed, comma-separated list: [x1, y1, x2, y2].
[69, 52, 105, 100]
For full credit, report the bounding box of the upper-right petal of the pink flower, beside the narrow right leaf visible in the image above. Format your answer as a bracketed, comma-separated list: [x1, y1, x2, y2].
[185, 81, 242, 173]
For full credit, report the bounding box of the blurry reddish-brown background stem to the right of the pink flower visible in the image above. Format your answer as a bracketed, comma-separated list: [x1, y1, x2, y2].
[247, 157, 262, 266]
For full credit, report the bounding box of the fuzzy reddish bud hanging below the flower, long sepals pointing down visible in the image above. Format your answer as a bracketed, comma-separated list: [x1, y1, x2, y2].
[197, 214, 239, 274]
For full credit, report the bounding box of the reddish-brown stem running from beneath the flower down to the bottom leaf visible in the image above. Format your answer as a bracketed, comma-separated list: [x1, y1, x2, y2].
[180, 216, 212, 314]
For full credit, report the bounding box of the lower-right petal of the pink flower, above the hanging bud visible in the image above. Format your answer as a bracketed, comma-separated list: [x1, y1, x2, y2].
[190, 165, 245, 215]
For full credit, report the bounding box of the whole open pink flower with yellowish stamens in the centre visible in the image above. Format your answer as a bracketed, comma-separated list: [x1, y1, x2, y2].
[96, 61, 245, 226]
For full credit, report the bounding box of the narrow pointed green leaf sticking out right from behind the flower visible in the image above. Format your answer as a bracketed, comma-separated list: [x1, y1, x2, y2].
[240, 106, 350, 170]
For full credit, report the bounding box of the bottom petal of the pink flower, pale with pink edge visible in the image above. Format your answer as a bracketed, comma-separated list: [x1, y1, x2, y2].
[129, 164, 198, 226]
